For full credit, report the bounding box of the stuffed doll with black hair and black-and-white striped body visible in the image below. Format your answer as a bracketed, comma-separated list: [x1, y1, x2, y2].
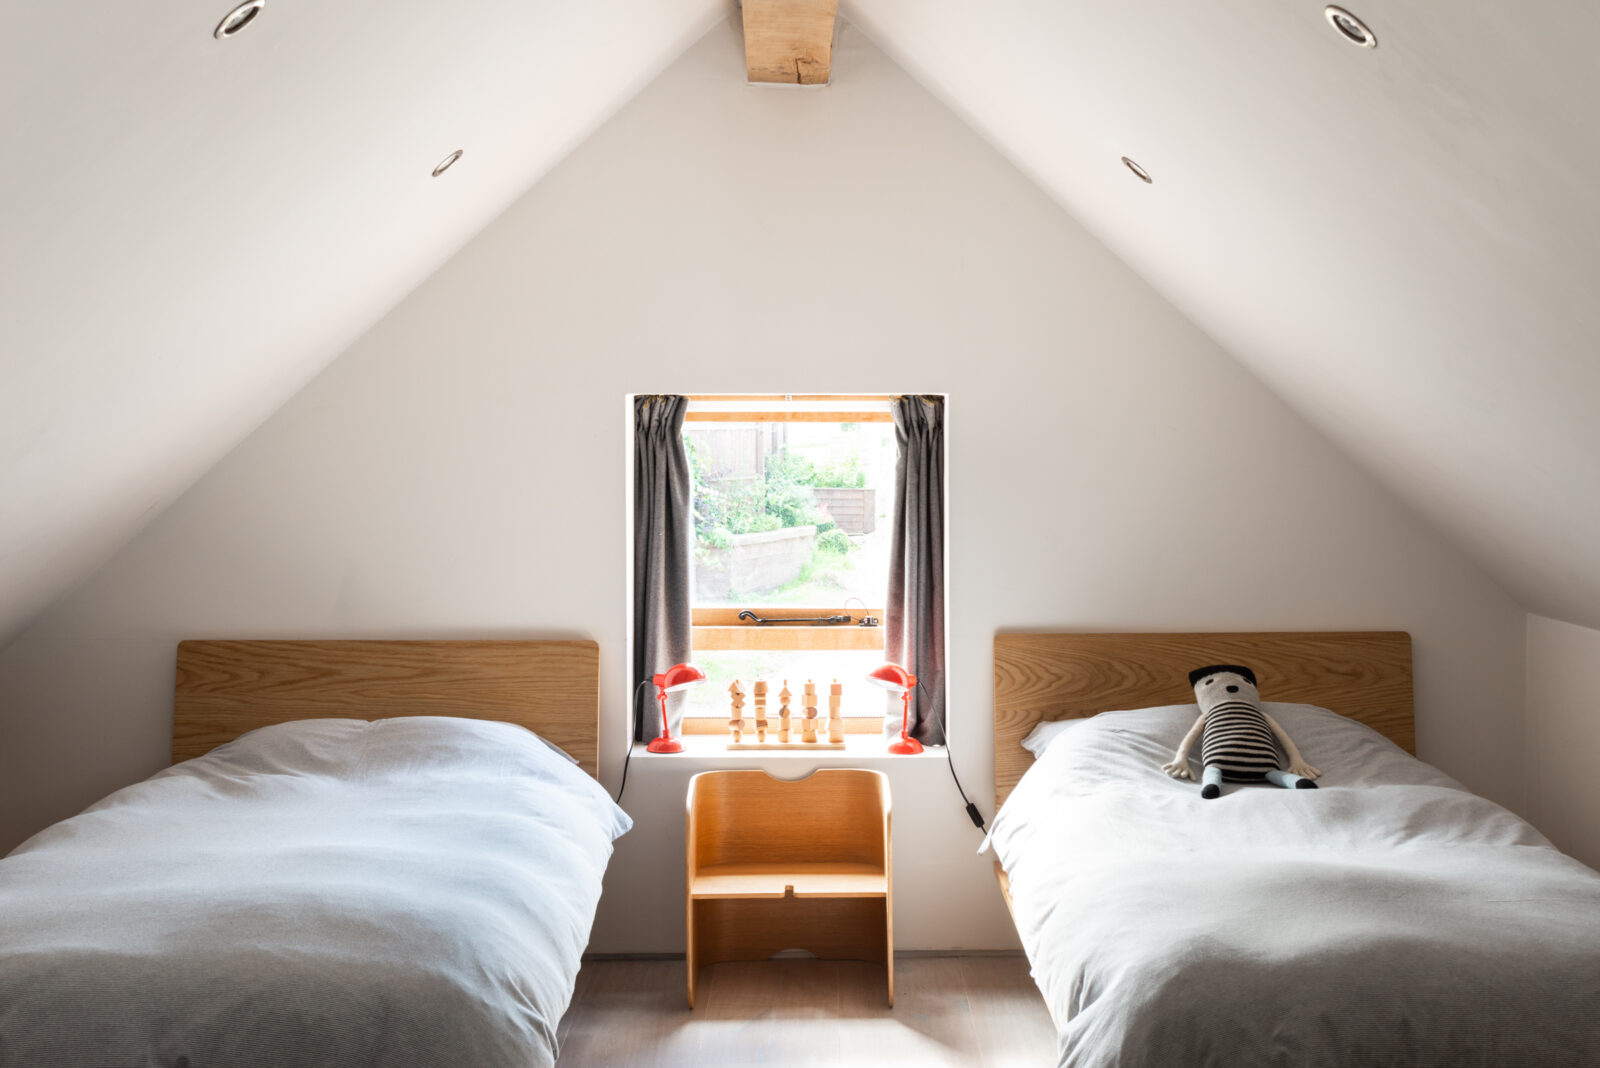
[1162, 664, 1322, 801]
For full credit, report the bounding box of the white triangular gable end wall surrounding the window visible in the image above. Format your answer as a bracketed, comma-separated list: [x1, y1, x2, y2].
[0, 16, 1523, 951]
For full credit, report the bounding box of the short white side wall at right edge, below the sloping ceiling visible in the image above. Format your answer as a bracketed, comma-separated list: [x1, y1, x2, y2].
[1526, 616, 1600, 868]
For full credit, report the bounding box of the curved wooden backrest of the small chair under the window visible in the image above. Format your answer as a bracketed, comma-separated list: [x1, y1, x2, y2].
[688, 767, 890, 868]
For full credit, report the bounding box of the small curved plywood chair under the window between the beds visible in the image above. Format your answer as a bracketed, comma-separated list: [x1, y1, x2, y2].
[685, 767, 894, 1009]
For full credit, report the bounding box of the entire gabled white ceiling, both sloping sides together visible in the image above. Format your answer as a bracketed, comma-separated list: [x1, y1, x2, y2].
[0, 0, 1600, 646]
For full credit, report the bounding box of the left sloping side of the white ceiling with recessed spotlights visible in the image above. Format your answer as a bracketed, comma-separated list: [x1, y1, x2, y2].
[0, 0, 728, 646]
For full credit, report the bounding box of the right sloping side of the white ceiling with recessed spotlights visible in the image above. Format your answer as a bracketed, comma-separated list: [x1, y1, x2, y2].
[846, 0, 1600, 627]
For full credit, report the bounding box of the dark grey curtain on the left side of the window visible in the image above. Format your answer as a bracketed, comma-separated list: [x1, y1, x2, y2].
[632, 395, 694, 740]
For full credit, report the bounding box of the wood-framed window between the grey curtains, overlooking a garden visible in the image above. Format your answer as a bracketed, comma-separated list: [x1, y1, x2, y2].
[683, 395, 896, 732]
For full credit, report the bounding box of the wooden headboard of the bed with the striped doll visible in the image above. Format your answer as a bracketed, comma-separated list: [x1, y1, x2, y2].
[995, 630, 1416, 811]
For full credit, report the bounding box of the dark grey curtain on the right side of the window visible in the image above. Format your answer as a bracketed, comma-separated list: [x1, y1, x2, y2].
[883, 397, 944, 745]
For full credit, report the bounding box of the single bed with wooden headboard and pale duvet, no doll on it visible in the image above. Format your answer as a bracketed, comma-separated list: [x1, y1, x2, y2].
[0, 641, 630, 1068]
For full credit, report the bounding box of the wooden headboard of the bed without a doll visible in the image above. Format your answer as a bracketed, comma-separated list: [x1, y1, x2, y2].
[173, 641, 600, 775]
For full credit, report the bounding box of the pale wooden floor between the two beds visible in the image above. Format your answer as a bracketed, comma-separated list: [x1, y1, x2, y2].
[558, 956, 1056, 1068]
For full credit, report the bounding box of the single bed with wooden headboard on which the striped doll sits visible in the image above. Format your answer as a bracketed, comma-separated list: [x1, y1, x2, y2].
[992, 633, 1600, 1068]
